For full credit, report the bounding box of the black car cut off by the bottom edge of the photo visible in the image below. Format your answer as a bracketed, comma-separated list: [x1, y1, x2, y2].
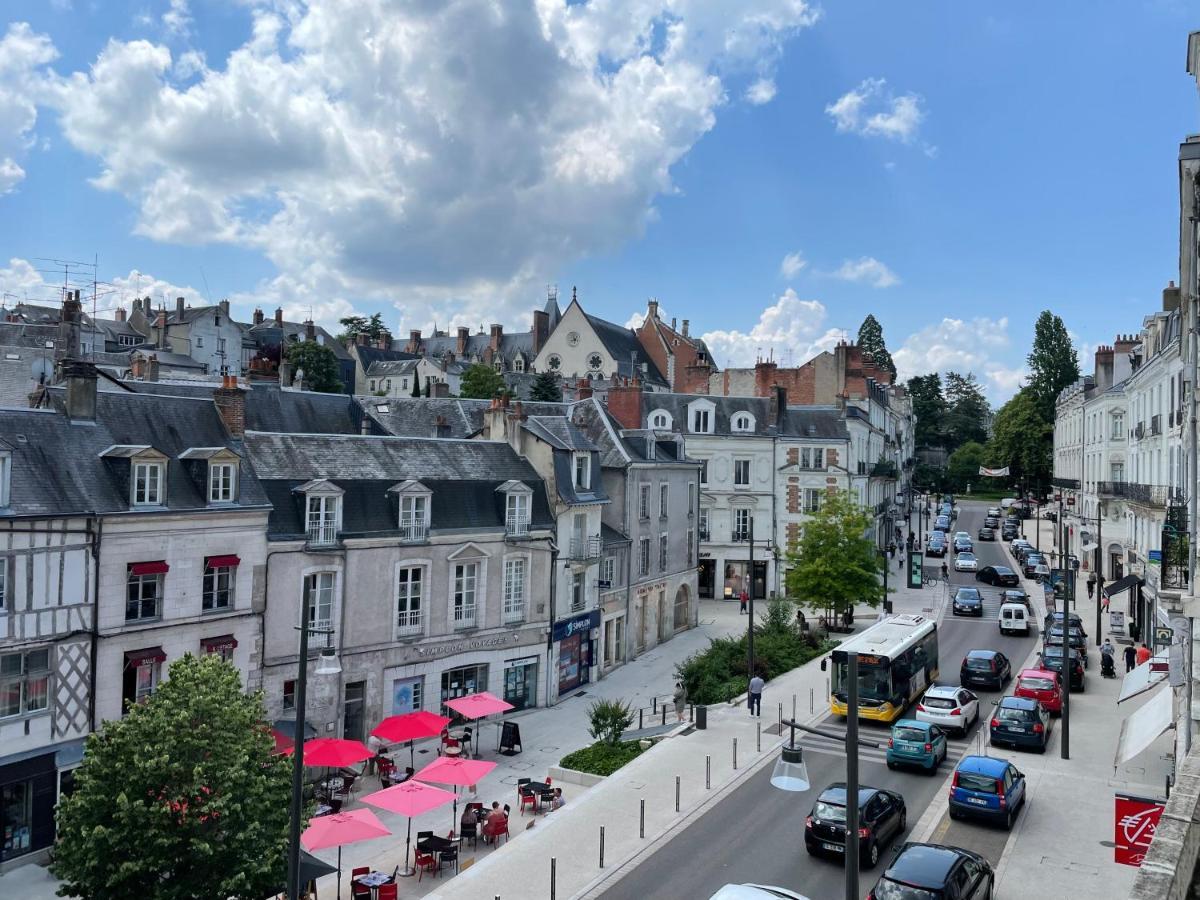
[866, 844, 996, 900]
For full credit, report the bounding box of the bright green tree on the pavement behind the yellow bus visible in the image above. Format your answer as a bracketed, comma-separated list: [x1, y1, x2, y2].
[787, 492, 883, 617]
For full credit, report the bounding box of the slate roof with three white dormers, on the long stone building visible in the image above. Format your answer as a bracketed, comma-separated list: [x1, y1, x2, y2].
[246, 432, 554, 539]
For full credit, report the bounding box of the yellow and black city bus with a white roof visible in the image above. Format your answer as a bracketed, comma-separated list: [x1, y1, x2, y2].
[829, 616, 937, 722]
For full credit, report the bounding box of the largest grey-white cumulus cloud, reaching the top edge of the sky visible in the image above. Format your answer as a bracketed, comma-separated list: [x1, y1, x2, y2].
[21, 0, 817, 326]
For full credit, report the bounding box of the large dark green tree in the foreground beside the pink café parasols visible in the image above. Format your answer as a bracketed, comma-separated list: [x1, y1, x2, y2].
[52, 654, 292, 900]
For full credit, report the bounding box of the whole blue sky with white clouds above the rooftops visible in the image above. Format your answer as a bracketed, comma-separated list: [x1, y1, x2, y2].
[0, 0, 1200, 401]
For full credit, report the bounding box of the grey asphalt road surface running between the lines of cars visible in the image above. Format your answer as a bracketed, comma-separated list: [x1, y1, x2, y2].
[604, 502, 1036, 900]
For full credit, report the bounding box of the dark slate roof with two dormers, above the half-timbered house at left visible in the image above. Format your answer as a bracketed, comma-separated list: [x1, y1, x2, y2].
[0, 386, 266, 516]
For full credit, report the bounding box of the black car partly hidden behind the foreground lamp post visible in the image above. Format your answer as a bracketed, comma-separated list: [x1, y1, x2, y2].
[804, 782, 908, 869]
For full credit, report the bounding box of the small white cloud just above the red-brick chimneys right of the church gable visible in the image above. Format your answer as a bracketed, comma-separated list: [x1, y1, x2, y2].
[702, 288, 846, 368]
